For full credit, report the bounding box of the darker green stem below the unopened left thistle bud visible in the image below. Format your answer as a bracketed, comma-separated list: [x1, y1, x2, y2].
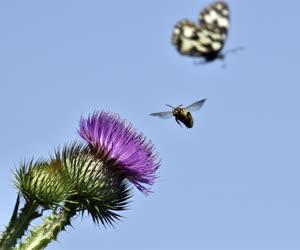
[0, 195, 41, 250]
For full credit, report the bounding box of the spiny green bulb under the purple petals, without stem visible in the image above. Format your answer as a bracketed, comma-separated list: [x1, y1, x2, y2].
[53, 143, 131, 225]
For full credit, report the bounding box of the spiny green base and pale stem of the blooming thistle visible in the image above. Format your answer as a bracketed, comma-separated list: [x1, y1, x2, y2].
[14, 143, 131, 250]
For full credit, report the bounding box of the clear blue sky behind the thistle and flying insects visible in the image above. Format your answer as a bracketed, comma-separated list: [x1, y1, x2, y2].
[0, 0, 300, 250]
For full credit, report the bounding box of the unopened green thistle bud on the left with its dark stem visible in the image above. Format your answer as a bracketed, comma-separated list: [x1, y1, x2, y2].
[0, 160, 69, 250]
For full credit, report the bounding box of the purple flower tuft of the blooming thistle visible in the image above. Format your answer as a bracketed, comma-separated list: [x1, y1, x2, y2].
[78, 111, 160, 194]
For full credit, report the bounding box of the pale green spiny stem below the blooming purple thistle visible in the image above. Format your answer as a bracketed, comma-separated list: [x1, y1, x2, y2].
[16, 210, 76, 250]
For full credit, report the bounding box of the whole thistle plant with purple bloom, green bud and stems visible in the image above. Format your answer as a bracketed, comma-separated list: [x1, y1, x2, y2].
[0, 112, 159, 249]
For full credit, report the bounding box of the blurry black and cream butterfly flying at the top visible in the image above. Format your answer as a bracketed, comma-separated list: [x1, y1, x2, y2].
[172, 1, 230, 62]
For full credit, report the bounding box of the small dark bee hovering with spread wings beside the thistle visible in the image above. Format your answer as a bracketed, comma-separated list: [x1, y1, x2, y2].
[150, 99, 206, 128]
